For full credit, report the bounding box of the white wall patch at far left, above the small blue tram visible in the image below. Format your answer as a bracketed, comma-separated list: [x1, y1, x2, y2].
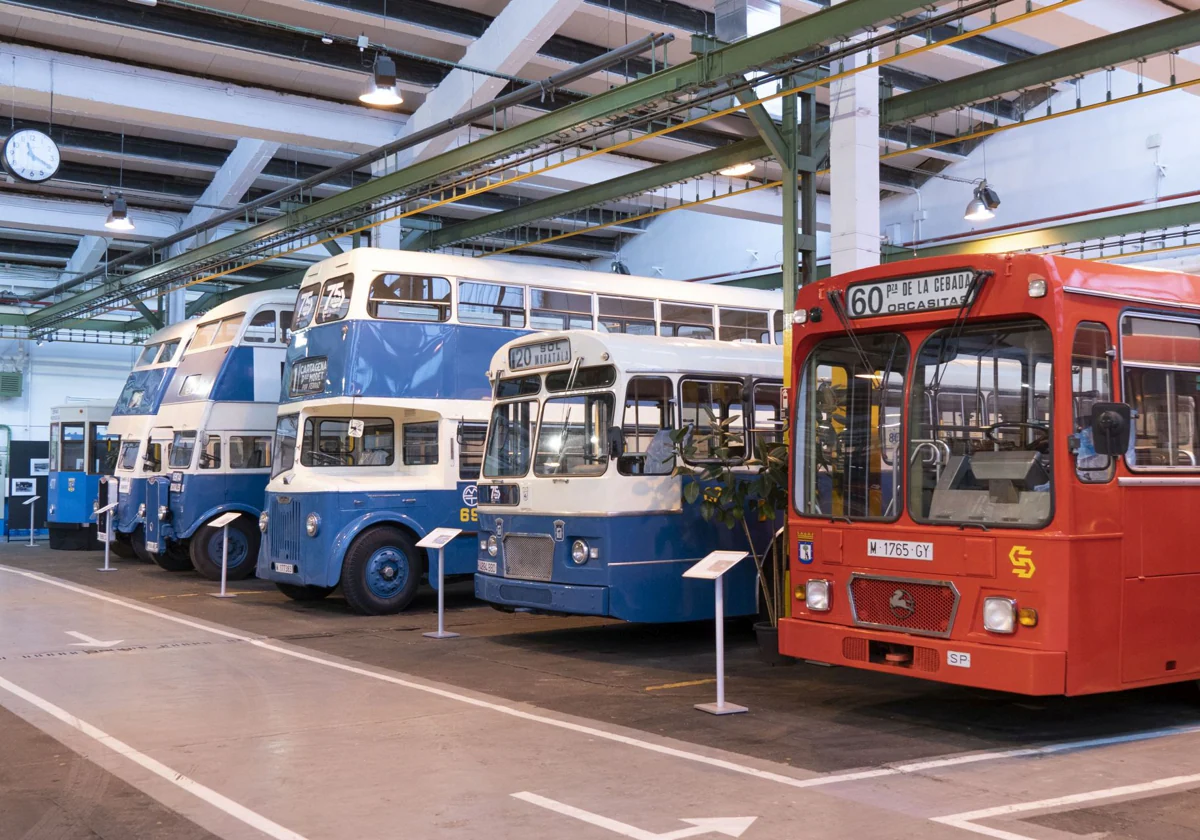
[0, 340, 142, 440]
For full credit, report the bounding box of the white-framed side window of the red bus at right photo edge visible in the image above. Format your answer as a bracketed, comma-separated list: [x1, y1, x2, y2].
[1121, 316, 1200, 469]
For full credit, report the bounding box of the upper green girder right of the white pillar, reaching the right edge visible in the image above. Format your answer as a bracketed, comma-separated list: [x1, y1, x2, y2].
[880, 12, 1200, 125]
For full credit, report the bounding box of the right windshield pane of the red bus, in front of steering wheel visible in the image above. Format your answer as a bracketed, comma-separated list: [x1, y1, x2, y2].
[908, 320, 1052, 528]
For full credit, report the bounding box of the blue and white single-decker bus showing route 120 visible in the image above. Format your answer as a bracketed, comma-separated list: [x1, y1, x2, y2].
[475, 332, 785, 622]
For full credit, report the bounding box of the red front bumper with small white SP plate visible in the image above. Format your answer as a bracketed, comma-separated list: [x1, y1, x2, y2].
[779, 618, 1067, 696]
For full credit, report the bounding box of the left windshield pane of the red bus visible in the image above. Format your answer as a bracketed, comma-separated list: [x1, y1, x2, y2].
[794, 332, 908, 520]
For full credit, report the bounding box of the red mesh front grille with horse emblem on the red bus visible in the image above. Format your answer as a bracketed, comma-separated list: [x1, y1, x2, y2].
[850, 575, 959, 638]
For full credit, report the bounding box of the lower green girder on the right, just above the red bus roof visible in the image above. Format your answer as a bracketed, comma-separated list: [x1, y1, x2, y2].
[884, 202, 1200, 262]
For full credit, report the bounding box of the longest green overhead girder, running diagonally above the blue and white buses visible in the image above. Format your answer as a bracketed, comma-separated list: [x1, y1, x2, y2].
[26, 0, 926, 329]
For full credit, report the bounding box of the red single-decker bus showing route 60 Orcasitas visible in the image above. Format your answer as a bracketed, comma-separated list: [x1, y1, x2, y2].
[779, 254, 1200, 695]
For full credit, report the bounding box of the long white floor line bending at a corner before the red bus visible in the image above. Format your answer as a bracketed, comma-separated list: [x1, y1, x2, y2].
[0, 565, 1200, 788]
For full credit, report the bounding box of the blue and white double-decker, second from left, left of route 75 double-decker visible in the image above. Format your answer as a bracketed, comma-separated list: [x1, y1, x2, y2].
[144, 292, 295, 580]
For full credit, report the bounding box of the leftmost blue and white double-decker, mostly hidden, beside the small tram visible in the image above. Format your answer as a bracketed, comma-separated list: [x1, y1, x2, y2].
[109, 320, 196, 563]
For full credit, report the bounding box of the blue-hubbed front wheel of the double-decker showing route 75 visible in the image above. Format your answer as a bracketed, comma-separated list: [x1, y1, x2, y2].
[342, 526, 422, 616]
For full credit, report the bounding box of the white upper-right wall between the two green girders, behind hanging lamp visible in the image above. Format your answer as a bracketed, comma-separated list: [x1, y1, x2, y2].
[882, 71, 1200, 242]
